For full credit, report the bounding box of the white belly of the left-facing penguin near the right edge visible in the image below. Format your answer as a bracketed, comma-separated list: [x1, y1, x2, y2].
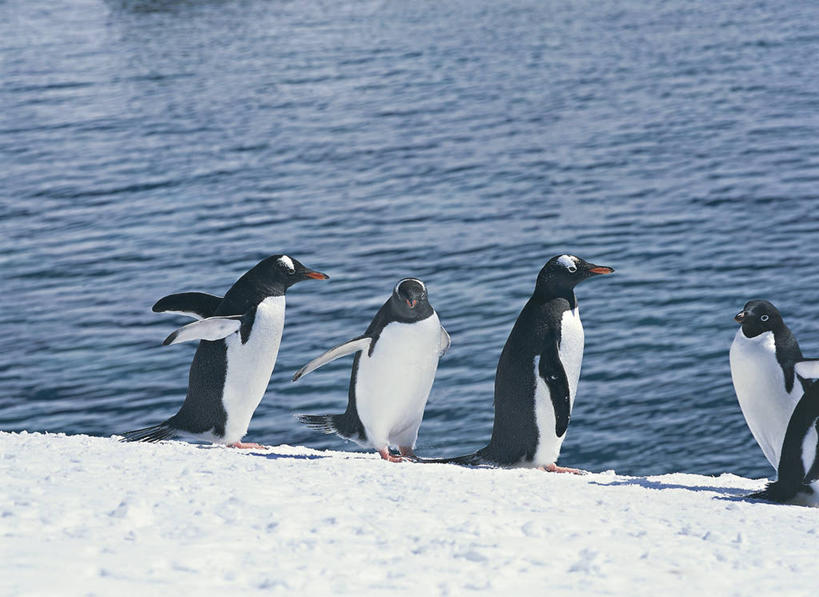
[729, 328, 802, 468]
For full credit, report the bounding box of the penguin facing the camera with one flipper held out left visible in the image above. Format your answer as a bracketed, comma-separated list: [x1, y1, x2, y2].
[293, 278, 449, 462]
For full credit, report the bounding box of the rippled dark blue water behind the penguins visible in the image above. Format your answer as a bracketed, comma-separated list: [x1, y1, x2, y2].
[0, 0, 819, 476]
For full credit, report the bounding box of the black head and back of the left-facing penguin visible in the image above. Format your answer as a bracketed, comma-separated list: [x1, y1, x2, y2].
[736, 300, 810, 393]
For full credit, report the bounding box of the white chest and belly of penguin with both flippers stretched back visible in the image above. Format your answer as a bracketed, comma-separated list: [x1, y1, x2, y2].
[222, 296, 285, 444]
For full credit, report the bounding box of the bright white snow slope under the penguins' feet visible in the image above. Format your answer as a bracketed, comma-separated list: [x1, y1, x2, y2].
[0, 432, 819, 596]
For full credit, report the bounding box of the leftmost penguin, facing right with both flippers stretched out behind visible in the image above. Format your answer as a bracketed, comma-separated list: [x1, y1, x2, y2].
[123, 255, 328, 448]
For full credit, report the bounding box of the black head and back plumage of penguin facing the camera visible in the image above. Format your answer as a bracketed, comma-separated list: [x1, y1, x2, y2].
[334, 278, 435, 441]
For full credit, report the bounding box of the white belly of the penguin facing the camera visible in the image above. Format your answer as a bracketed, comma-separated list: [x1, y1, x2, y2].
[354, 313, 441, 449]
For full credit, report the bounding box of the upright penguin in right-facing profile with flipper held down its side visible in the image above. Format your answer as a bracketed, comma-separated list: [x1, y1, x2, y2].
[425, 255, 614, 473]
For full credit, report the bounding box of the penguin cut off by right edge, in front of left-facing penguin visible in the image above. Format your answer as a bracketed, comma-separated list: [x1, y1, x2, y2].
[748, 378, 819, 505]
